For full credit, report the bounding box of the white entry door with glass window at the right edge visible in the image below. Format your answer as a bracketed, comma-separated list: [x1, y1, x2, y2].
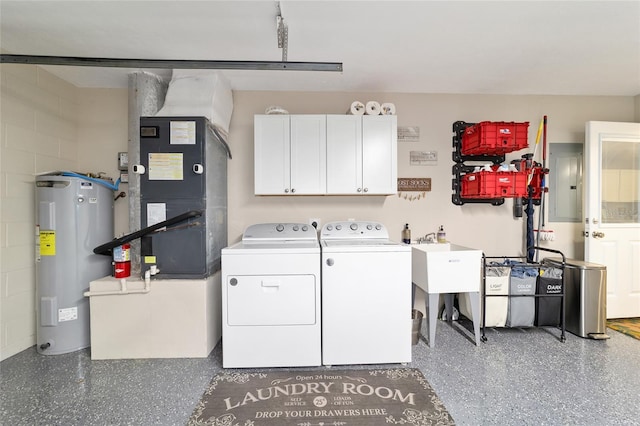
[584, 121, 640, 318]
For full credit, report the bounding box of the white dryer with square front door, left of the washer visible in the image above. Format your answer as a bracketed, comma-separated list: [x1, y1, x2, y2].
[222, 223, 322, 368]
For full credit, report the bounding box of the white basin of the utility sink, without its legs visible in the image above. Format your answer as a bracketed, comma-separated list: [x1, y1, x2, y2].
[411, 243, 482, 293]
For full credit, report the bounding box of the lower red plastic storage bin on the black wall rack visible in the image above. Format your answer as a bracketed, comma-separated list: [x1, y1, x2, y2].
[460, 171, 527, 198]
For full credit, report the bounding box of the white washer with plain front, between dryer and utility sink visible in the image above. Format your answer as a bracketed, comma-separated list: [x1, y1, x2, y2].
[320, 221, 412, 365]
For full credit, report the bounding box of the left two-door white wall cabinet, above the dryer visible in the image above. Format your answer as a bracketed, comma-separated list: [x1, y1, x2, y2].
[254, 115, 327, 195]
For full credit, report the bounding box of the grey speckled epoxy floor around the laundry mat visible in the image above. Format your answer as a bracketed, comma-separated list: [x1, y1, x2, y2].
[0, 321, 640, 426]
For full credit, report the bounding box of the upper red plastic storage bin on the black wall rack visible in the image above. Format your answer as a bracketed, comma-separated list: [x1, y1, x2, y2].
[460, 121, 529, 155]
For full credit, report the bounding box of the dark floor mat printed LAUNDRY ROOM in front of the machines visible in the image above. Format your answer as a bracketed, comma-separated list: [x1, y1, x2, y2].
[188, 368, 455, 426]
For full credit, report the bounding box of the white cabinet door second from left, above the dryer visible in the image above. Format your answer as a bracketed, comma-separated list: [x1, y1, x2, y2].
[290, 115, 327, 195]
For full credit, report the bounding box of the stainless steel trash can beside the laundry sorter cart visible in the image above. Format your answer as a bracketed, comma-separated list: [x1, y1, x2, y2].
[542, 257, 609, 339]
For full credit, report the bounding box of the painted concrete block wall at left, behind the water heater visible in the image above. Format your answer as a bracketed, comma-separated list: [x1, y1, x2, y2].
[0, 64, 78, 360]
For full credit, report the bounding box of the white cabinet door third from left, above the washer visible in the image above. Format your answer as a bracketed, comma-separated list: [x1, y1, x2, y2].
[327, 115, 362, 194]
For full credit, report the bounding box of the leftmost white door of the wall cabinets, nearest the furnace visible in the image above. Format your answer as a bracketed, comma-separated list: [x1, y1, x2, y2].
[253, 115, 291, 195]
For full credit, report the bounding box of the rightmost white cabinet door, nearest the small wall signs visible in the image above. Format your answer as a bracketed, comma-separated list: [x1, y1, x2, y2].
[362, 115, 398, 195]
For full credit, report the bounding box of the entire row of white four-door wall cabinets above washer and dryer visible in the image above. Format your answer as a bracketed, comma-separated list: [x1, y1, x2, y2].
[255, 115, 398, 195]
